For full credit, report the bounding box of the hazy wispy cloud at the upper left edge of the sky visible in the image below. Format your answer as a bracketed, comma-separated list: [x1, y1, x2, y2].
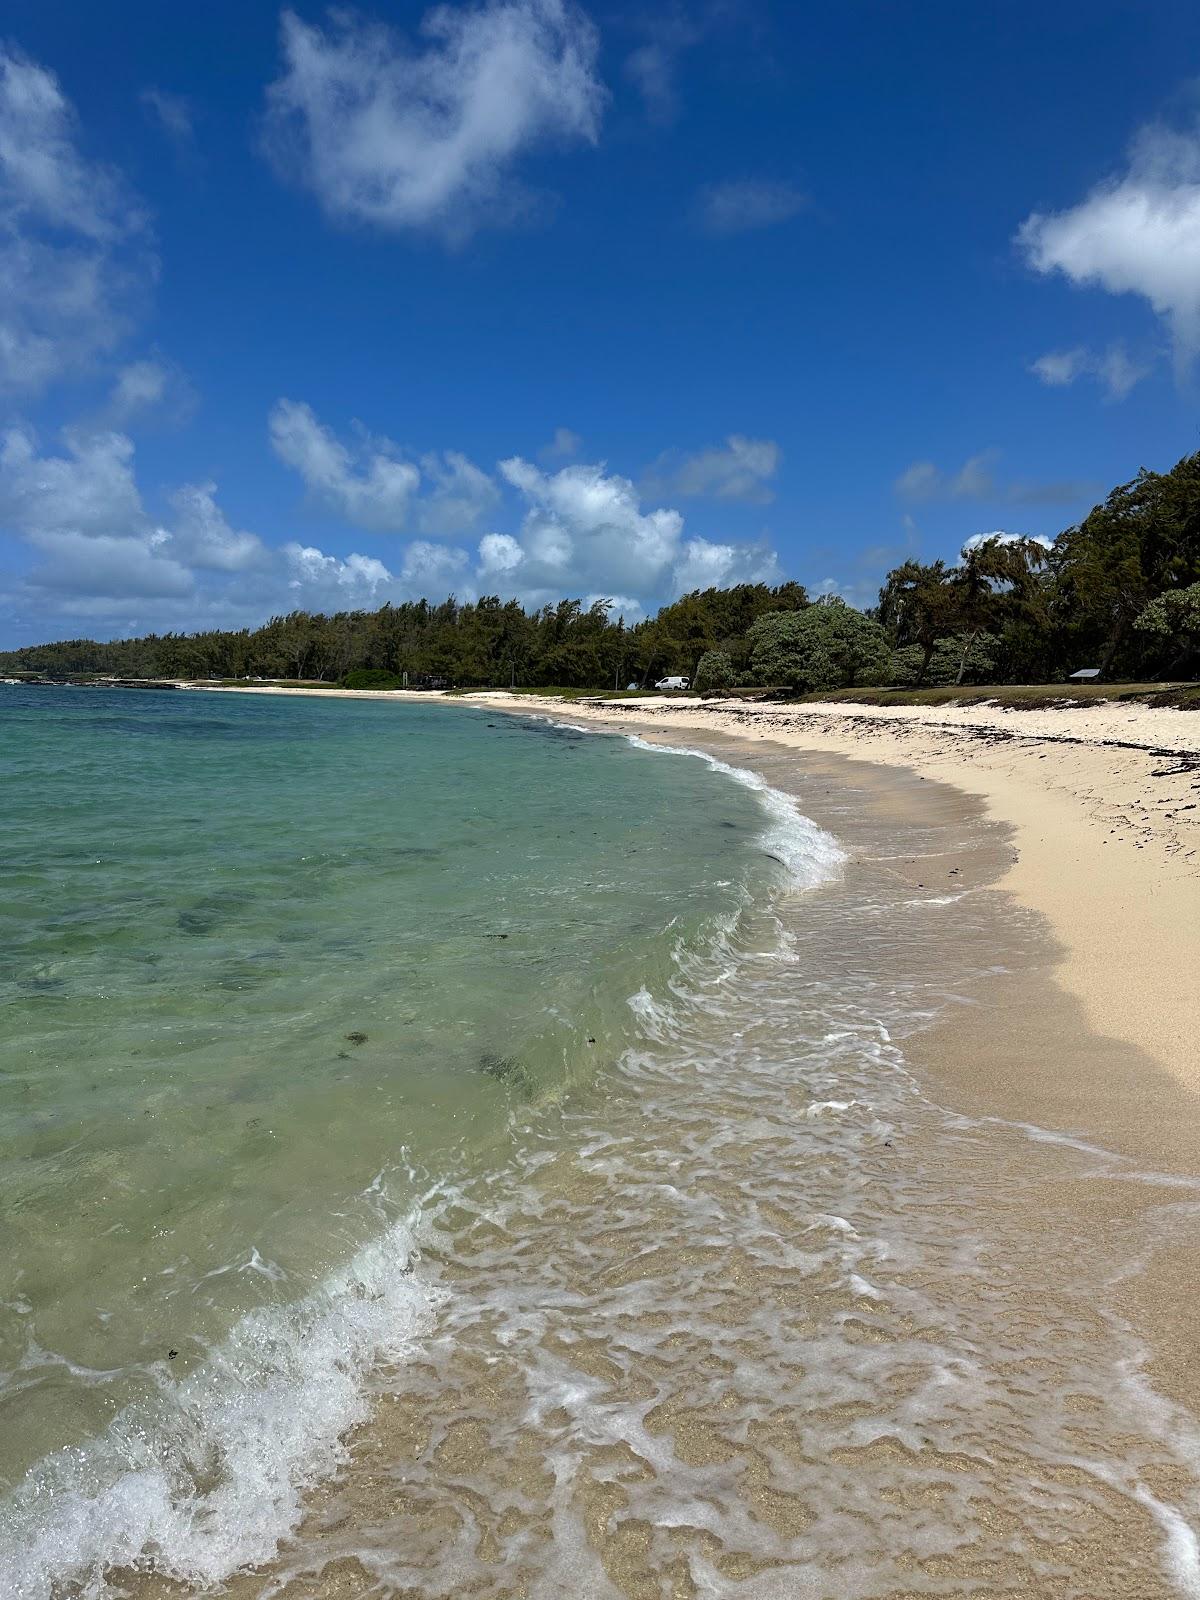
[0, 48, 155, 389]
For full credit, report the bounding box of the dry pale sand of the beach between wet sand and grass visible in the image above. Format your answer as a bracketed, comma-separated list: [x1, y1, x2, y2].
[202, 686, 1200, 1126]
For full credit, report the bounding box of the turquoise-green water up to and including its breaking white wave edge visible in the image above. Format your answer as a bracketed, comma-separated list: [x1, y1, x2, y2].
[0, 686, 819, 1571]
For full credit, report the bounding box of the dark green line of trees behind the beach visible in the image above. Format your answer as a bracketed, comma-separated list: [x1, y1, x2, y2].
[0, 453, 1200, 690]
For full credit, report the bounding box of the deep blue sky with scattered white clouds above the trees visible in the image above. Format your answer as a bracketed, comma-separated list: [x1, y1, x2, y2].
[0, 0, 1200, 646]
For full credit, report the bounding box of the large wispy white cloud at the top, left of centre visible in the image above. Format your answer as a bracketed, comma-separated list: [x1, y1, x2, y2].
[267, 0, 605, 240]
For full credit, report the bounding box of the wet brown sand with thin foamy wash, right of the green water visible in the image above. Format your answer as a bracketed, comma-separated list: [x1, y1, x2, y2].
[127, 702, 1200, 1600]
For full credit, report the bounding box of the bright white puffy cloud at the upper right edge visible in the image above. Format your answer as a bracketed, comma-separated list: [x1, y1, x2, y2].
[1016, 116, 1200, 363]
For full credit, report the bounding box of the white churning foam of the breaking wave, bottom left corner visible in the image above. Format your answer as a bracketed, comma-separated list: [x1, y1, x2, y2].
[0, 1216, 443, 1600]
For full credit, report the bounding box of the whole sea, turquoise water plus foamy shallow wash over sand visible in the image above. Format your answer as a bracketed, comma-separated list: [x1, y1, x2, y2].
[0, 688, 1200, 1600]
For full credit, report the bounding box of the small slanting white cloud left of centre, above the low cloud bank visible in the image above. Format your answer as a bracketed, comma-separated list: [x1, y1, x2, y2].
[269, 400, 421, 533]
